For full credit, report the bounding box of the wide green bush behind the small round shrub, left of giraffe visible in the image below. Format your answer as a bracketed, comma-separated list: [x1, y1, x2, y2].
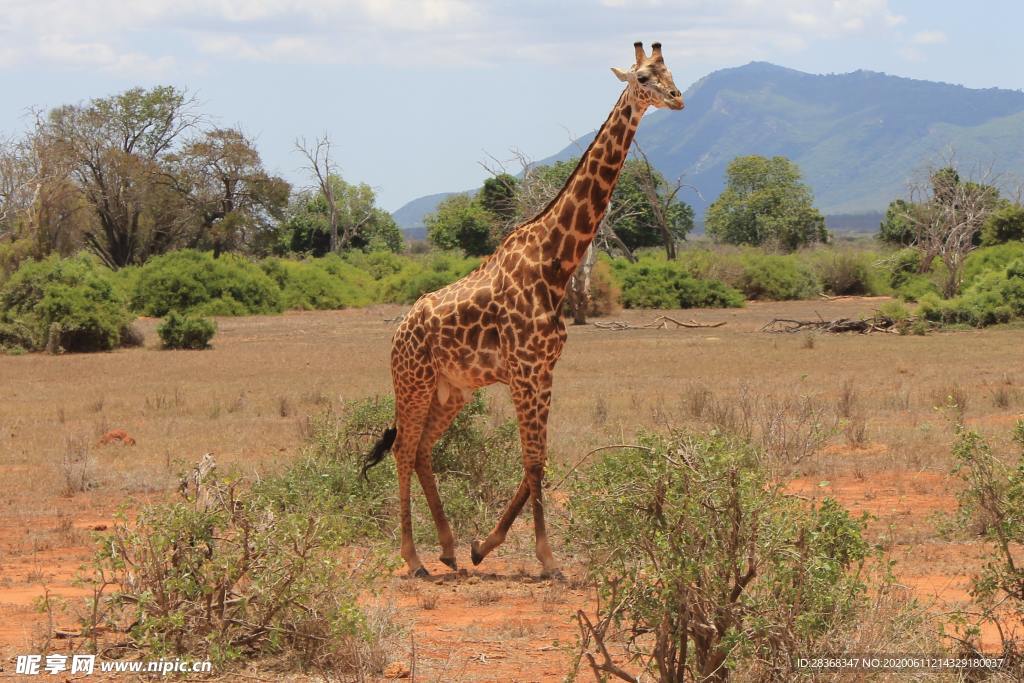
[132, 249, 283, 316]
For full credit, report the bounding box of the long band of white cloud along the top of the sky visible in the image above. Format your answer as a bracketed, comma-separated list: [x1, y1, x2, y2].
[0, 0, 913, 73]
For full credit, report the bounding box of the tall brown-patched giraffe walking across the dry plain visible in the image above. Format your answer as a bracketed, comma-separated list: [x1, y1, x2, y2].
[362, 42, 683, 577]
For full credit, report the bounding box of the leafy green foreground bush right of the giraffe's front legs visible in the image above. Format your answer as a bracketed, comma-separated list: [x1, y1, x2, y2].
[567, 432, 869, 682]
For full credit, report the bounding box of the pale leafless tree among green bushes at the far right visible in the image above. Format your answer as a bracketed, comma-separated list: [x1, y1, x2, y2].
[903, 160, 999, 298]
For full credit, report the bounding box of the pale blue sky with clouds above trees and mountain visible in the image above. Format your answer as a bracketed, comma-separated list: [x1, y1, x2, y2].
[0, 0, 1024, 210]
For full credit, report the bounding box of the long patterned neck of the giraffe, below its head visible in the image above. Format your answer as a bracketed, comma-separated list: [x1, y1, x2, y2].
[537, 86, 646, 292]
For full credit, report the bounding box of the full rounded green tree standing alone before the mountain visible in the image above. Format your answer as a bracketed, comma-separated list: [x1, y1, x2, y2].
[705, 155, 828, 251]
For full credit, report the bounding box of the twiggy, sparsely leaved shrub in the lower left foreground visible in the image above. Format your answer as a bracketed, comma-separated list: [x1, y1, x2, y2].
[76, 460, 387, 672]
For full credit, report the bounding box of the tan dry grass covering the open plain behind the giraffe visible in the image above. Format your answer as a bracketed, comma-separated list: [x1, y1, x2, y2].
[0, 299, 1021, 680]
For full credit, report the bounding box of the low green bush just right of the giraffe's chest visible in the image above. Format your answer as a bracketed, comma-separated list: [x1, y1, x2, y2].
[611, 256, 743, 308]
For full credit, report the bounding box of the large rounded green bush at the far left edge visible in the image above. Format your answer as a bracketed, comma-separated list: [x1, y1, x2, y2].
[0, 254, 131, 351]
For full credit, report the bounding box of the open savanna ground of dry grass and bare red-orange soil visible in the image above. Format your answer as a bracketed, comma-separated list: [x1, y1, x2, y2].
[0, 299, 1024, 681]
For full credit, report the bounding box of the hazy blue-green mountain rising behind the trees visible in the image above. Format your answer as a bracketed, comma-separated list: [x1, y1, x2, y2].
[395, 61, 1024, 233]
